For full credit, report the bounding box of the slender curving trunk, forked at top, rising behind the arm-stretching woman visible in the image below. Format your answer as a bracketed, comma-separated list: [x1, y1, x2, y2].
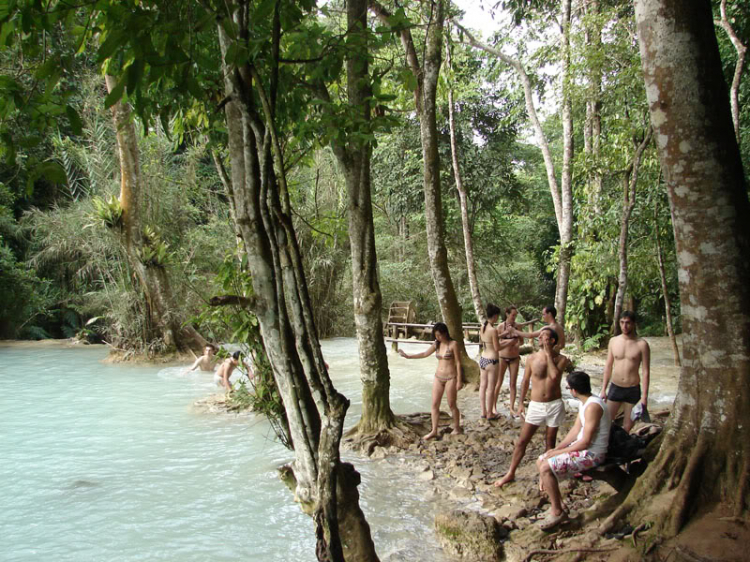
[370, 0, 479, 382]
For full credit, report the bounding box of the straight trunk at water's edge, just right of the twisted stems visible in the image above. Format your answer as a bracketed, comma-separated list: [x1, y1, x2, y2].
[334, 0, 395, 433]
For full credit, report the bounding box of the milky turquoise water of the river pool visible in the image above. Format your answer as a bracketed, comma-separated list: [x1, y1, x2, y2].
[0, 339, 442, 562]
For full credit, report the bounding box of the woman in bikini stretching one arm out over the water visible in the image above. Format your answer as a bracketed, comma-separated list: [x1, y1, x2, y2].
[398, 322, 463, 440]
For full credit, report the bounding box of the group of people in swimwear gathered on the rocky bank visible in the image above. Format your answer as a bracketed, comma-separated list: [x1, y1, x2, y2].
[399, 304, 650, 529]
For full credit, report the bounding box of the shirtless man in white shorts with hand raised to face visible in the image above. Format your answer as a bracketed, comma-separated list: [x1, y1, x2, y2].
[495, 327, 569, 487]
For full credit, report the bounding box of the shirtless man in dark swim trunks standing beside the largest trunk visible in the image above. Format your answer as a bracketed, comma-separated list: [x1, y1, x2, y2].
[601, 310, 651, 431]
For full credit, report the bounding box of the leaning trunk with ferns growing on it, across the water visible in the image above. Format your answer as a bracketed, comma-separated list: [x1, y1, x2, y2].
[105, 75, 206, 351]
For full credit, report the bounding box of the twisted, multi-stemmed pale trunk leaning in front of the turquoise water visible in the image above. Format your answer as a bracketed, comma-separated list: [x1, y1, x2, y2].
[217, 6, 377, 561]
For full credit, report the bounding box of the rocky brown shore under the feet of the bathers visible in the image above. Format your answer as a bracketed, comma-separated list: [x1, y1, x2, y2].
[345, 385, 668, 561]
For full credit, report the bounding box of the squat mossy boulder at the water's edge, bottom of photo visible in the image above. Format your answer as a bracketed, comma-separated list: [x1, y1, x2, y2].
[435, 510, 507, 562]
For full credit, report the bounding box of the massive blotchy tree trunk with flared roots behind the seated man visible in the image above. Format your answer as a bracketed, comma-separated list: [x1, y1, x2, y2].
[605, 0, 750, 535]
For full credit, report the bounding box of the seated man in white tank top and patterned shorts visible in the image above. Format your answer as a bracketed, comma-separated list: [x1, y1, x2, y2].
[537, 371, 612, 531]
